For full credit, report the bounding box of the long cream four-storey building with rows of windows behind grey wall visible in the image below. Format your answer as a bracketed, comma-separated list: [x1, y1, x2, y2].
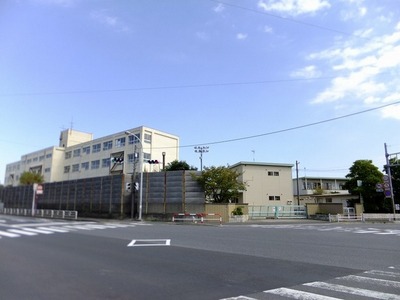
[4, 126, 179, 186]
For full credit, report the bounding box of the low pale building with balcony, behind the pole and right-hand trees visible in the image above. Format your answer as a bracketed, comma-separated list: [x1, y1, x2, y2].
[293, 177, 357, 207]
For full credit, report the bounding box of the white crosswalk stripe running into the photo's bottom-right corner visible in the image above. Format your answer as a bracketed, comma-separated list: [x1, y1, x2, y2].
[303, 281, 400, 300]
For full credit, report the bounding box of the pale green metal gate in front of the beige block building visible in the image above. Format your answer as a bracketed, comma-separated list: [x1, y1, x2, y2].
[248, 205, 307, 219]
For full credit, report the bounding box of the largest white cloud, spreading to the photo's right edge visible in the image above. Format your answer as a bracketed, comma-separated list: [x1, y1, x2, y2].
[308, 23, 400, 119]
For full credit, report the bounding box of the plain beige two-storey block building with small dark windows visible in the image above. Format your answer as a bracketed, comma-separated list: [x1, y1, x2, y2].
[231, 162, 293, 206]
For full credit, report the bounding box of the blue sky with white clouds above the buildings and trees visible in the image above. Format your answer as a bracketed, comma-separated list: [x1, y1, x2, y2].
[0, 0, 400, 183]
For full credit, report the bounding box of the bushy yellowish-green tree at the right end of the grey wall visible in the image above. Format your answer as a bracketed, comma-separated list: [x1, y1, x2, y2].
[195, 166, 246, 203]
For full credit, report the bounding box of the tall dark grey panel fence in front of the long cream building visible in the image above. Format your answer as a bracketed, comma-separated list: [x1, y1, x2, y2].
[0, 171, 205, 218]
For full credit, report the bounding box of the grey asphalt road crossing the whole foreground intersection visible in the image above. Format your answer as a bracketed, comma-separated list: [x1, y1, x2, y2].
[0, 215, 400, 300]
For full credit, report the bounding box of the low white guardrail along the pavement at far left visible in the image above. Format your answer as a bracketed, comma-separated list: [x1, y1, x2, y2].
[0, 208, 78, 220]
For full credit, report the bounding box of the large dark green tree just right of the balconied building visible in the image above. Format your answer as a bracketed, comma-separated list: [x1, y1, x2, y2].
[345, 160, 391, 212]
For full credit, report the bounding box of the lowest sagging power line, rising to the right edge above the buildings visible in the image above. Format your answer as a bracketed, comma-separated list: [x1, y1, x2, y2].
[180, 101, 400, 148]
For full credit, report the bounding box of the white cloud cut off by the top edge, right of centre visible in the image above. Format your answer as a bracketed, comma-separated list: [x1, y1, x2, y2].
[258, 0, 331, 16]
